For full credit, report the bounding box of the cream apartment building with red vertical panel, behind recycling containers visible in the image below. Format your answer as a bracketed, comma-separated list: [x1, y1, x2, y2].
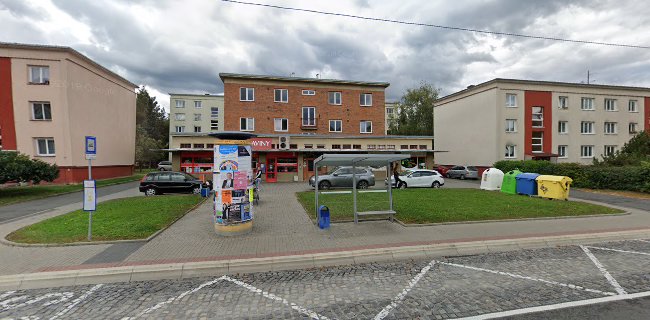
[434, 79, 650, 166]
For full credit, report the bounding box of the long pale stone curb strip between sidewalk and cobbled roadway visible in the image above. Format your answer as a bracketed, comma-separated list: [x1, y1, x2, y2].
[0, 229, 650, 290]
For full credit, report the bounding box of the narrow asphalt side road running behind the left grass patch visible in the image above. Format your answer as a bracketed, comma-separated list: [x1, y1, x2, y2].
[0, 181, 140, 224]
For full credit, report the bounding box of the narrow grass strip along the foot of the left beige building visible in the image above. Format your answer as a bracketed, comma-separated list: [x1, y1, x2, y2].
[0, 172, 146, 206]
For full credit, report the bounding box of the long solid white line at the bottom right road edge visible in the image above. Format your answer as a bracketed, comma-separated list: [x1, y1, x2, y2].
[457, 291, 650, 320]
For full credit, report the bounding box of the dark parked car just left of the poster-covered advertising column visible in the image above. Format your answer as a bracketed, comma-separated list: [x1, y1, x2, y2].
[140, 171, 205, 196]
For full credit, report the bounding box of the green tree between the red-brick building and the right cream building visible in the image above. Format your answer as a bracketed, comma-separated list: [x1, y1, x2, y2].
[388, 82, 440, 136]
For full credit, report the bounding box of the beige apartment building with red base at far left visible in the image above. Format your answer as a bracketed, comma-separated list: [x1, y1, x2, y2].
[0, 43, 138, 183]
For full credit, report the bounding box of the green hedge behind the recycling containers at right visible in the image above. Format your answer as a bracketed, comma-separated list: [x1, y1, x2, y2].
[494, 160, 650, 192]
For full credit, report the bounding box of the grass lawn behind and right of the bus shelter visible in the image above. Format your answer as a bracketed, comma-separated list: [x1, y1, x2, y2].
[297, 188, 622, 224]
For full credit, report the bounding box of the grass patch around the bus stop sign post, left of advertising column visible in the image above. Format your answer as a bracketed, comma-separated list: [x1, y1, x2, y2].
[7, 195, 204, 243]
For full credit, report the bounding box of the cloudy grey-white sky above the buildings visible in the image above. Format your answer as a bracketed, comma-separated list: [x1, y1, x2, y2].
[0, 0, 650, 111]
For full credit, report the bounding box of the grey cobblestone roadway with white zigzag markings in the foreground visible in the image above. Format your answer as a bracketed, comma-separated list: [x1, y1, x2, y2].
[0, 240, 650, 319]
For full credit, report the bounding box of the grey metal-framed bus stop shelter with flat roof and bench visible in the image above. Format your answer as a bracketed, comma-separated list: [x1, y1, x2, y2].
[314, 153, 411, 223]
